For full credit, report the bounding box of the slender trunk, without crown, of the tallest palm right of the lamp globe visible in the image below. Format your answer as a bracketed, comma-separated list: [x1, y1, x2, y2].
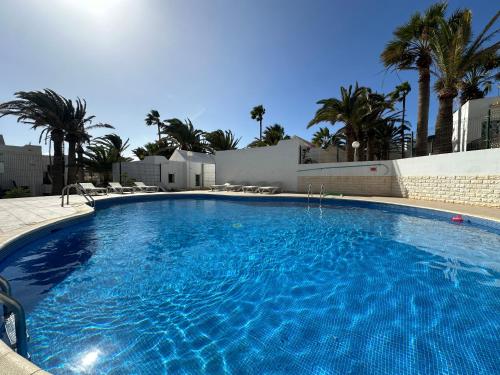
[416, 66, 431, 156]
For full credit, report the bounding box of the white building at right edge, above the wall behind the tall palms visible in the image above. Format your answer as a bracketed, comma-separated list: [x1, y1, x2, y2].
[452, 96, 500, 152]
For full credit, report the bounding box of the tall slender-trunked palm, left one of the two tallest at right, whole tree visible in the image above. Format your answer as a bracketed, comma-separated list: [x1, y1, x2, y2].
[381, 3, 446, 156]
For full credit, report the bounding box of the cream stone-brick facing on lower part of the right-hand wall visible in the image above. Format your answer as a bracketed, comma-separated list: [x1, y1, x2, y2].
[392, 175, 500, 208]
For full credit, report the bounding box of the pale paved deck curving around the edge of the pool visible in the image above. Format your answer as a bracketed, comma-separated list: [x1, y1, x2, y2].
[0, 190, 500, 375]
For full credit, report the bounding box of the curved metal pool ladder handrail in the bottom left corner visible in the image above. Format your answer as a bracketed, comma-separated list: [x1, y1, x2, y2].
[0, 276, 29, 359]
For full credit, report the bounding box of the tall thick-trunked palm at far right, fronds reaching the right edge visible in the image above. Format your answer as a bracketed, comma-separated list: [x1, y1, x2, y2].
[431, 9, 500, 153]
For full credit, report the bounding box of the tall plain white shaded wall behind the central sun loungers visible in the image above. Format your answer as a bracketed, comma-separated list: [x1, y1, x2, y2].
[215, 139, 300, 191]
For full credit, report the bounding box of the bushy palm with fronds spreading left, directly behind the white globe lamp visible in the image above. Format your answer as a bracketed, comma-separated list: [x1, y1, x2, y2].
[307, 83, 366, 161]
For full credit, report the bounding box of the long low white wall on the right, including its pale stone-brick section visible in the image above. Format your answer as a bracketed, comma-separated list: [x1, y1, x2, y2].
[297, 149, 500, 207]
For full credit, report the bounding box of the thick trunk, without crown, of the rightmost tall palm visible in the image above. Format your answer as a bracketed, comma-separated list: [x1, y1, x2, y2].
[434, 89, 456, 154]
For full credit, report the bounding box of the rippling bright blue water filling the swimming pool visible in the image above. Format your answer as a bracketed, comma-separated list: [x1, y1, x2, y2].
[0, 199, 500, 375]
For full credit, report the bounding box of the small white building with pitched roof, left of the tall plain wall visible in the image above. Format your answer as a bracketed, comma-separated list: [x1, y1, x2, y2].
[113, 150, 215, 190]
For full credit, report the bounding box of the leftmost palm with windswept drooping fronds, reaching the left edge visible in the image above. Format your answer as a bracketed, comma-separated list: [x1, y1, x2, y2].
[0, 89, 74, 195]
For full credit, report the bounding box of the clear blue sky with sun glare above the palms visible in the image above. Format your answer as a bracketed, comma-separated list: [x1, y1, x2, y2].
[0, 0, 498, 156]
